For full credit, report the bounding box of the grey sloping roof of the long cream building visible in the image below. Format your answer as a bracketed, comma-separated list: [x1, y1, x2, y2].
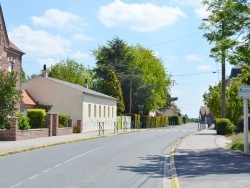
[44, 77, 117, 100]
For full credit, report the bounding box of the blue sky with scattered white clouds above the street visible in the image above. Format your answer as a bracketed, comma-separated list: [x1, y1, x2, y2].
[1, 0, 232, 117]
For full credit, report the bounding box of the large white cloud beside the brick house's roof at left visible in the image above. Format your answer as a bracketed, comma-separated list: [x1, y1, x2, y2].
[8, 25, 71, 56]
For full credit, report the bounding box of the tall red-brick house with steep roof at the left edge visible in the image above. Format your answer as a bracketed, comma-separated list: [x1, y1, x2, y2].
[0, 5, 25, 87]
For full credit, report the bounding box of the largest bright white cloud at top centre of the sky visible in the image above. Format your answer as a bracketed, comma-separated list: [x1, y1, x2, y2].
[98, 0, 186, 32]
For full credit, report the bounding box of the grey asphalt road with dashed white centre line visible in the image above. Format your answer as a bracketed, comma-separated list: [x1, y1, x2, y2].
[0, 124, 197, 188]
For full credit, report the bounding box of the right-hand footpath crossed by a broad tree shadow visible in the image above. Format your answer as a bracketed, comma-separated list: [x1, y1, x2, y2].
[174, 127, 250, 188]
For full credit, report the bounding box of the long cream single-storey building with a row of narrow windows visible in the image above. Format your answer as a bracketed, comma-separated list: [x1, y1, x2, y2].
[22, 76, 117, 131]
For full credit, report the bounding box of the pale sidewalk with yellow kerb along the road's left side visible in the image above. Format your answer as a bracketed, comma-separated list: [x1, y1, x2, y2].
[0, 129, 138, 157]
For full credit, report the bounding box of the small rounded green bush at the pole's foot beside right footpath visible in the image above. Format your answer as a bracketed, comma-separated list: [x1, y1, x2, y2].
[215, 118, 235, 135]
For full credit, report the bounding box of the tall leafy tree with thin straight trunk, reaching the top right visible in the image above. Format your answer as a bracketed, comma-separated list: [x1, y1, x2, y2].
[200, 0, 249, 117]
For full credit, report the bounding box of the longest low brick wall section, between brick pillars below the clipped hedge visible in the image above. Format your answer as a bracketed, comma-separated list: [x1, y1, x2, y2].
[16, 128, 49, 140]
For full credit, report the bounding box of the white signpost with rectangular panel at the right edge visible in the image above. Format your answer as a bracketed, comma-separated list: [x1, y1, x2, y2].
[239, 85, 250, 154]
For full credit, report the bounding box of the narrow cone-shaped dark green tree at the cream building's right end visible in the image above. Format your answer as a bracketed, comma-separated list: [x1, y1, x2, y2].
[105, 70, 125, 115]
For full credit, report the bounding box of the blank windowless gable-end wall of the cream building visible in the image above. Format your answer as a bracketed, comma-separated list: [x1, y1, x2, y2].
[22, 77, 82, 125]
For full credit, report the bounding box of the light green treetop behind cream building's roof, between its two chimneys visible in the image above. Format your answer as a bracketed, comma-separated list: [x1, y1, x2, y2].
[48, 59, 92, 87]
